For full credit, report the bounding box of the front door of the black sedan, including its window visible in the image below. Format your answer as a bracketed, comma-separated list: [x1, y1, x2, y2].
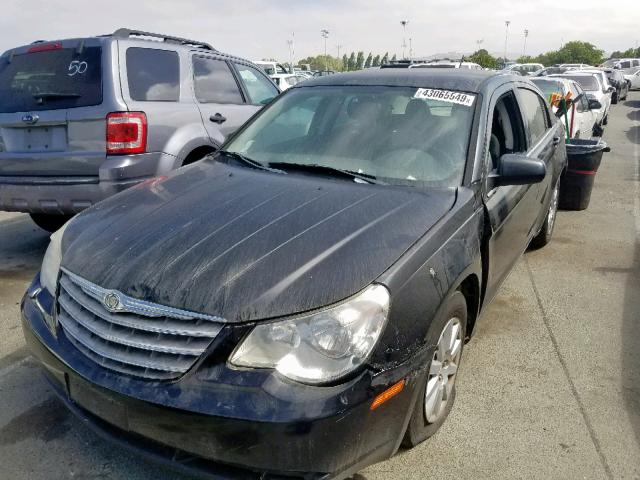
[484, 86, 540, 298]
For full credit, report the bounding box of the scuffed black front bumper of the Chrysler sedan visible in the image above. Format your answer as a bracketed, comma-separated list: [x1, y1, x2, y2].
[22, 280, 416, 479]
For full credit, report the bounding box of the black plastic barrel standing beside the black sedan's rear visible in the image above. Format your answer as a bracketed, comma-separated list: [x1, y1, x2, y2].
[558, 139, 611, 210]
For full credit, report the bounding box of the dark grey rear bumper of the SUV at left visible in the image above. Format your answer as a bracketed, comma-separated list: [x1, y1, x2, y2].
[0, 153, 176, 214]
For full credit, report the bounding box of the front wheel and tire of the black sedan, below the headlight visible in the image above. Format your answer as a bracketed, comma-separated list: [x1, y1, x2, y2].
[402, 290, 467, 448]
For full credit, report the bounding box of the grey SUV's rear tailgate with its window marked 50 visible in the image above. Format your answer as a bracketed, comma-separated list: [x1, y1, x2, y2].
[0, 39, 113, 177]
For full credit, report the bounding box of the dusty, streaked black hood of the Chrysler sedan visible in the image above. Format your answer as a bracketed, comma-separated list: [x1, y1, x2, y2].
[62, 160, 456, 322]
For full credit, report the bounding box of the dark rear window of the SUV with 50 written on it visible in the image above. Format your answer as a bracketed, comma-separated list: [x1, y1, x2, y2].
[0, 47, 102, 113]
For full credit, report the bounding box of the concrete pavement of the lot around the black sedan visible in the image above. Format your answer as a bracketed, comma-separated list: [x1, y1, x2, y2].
[0, 92, 640, 480]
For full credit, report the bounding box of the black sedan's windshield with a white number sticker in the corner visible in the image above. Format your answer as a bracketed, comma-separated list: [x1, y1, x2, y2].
[225, 86, 476, 187]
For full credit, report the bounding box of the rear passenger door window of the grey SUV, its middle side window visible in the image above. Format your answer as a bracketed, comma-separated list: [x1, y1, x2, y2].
[193, 57, 244, 103]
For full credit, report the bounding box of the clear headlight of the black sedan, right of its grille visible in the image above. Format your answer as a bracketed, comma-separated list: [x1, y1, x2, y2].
[230, 285, 389, 384]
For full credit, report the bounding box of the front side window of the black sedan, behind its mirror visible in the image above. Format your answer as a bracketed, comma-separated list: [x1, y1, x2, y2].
[487, 92, 526, 171]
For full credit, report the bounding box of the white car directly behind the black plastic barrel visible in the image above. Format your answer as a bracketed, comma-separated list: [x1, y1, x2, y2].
[531, 77, 600, 138]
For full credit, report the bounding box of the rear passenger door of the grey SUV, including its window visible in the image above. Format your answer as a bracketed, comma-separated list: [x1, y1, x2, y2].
[192, 53, 256, 146]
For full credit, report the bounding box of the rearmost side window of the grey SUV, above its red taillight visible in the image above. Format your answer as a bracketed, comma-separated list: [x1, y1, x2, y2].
[127, 47, 180, 102]
